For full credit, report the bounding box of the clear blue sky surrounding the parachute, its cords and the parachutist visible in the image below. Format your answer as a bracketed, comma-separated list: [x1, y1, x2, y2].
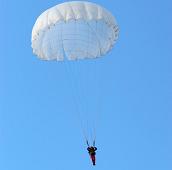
[0, 0, 172, 170]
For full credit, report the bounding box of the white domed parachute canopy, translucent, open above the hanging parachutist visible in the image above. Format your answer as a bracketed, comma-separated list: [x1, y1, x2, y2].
[32, 1, 119, 61]
